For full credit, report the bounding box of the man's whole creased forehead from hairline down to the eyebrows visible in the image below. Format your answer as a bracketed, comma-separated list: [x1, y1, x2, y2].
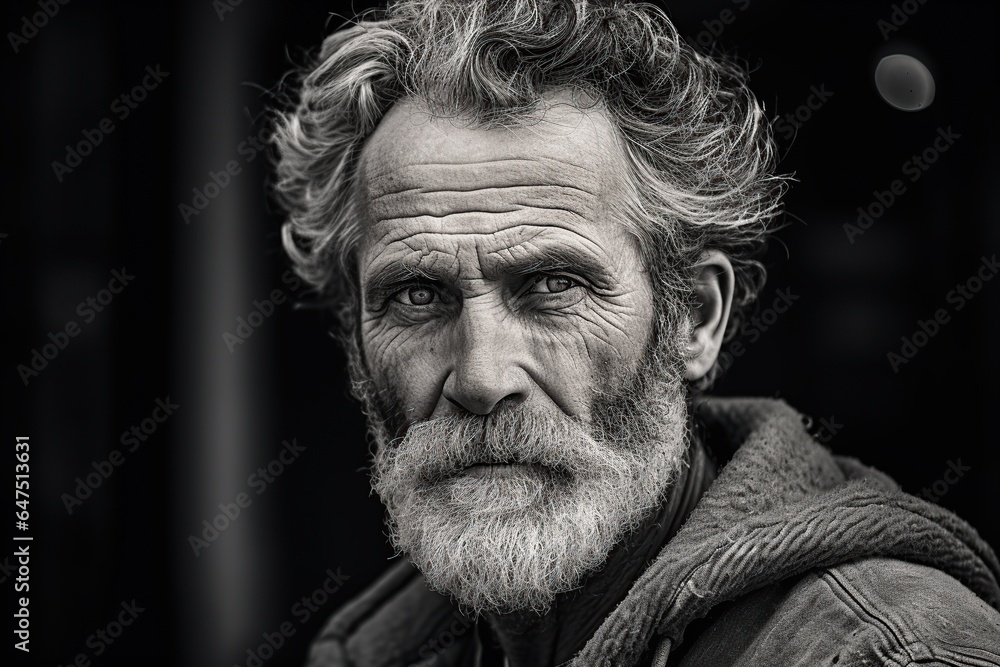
[359, 95, 624, 284]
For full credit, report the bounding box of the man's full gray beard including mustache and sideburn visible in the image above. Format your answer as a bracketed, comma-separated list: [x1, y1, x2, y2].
[354, 314, 688, 614]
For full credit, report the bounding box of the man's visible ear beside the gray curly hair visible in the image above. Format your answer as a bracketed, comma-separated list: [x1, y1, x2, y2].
[684, 250, 735, 380]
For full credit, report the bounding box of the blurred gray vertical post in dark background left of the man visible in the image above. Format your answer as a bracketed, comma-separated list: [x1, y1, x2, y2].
[172, 3, 272, 667]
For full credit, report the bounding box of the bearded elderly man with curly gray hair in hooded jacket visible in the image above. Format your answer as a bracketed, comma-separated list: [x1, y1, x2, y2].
[276, 0, 1000, 667]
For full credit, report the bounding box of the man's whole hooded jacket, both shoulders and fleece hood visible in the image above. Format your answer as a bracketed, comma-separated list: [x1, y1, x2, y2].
[309, 398, 1000, 667]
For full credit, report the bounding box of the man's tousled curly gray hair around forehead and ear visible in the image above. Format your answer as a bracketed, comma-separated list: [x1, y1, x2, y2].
[273, 0, 787, 383]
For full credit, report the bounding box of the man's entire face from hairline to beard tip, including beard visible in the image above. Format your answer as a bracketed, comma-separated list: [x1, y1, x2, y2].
[358, 96, 686, 610]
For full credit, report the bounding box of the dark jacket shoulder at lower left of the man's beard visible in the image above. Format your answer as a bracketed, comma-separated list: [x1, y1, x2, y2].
[308, 562, 474, 667]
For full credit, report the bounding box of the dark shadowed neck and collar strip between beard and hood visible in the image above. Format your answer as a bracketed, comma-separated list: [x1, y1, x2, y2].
[486, 441, 714, 667]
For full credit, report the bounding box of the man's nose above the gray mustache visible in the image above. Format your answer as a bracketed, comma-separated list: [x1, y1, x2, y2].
[442, 307, 531, 415]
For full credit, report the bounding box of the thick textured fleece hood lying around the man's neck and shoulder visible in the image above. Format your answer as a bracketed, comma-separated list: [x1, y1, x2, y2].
[570, 398, 1000, 667]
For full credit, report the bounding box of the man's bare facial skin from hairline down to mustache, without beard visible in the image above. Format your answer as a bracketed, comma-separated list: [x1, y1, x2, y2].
[360, 95, 654, 421]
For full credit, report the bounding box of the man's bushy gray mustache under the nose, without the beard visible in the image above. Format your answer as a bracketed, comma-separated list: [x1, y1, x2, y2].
[374, 407, 596, 484]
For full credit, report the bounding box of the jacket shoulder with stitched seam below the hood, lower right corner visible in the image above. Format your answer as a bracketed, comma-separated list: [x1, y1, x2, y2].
[677, 558, 1000, 667]
